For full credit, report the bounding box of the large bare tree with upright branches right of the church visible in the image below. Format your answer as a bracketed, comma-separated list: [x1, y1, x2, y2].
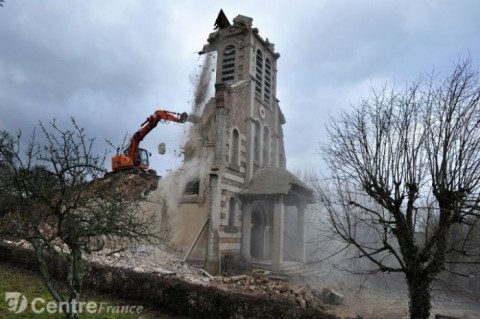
[316, 59, 480, 318]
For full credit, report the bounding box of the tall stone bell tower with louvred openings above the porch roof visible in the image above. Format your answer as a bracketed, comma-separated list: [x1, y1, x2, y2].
[203, 11, 285, 182]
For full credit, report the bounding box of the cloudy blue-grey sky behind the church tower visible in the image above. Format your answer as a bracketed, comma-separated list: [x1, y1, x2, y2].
[0, 0, 480, 174]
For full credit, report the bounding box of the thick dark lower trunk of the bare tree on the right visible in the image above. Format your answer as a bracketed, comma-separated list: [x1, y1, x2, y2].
[407, 271, 432, 319]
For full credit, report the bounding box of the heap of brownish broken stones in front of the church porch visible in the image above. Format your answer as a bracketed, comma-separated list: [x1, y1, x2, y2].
[214, 269, 325, 310]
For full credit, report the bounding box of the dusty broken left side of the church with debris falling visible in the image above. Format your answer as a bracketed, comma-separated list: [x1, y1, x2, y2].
[150, 54, 216, 261]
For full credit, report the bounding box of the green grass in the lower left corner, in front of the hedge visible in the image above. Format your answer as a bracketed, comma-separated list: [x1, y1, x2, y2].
[0, 263, 173, 319]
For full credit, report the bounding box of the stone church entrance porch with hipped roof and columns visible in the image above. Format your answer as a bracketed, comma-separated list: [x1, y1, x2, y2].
[241, 168, 313, 272]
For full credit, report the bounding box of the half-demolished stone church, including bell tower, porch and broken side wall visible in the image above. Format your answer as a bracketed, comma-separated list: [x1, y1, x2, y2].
[162, 12, 312, 273]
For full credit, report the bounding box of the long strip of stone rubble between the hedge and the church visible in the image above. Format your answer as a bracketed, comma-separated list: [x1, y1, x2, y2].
[6, 241, 344, 310]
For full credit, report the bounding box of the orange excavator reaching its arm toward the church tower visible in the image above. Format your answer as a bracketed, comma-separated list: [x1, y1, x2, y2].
[112, 110, 188, 172]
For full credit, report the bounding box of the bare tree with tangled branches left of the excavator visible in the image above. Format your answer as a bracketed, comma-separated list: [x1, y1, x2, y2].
[0, 119, 156, 318]
